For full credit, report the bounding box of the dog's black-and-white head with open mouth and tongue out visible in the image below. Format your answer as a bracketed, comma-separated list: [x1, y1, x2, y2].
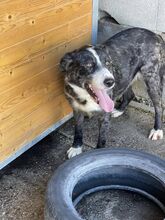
[60, 46, 115, 111]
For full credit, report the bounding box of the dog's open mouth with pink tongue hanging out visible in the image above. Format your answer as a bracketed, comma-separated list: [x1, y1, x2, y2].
[85, 83, 114, 112]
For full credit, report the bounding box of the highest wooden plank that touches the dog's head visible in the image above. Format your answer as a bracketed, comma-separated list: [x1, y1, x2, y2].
[0, 32, 90, 95]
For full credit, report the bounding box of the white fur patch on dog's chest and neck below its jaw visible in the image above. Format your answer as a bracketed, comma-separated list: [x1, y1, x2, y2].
[67, 84, 101, 112]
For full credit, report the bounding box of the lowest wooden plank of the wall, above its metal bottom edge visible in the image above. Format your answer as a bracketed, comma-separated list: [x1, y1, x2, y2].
[0, 95, 71, 160]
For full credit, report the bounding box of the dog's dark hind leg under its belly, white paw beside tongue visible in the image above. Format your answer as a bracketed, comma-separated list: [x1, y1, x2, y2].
[111, 86, 135, 118]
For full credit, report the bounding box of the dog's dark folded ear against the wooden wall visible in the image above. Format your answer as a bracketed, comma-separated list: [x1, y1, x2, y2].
[60, 51, 75, 72]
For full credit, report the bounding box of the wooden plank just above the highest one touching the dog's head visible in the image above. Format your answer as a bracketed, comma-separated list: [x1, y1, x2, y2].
[0, 13, 91, 69]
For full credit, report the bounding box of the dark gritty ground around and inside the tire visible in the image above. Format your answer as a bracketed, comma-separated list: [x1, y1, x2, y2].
[0, 104, 165, 220]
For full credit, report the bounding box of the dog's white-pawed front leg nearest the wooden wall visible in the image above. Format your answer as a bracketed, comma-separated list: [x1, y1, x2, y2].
[67, 112, 84, 158]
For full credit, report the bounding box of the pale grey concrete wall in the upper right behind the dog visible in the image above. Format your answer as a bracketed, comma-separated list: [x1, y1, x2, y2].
[99, 0, 165, 32]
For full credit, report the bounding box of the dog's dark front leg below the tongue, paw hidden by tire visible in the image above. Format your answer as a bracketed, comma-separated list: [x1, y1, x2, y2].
[97, 113, 110, 148]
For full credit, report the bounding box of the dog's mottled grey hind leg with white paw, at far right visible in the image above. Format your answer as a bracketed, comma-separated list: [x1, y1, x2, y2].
[141, 64, 163, 140]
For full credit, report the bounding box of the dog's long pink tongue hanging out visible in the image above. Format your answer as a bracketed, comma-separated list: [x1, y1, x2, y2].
[92, 88, 114, 112]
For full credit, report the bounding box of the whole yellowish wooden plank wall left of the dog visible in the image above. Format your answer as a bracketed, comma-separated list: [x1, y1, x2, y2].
[0, 0, 92, 162]
